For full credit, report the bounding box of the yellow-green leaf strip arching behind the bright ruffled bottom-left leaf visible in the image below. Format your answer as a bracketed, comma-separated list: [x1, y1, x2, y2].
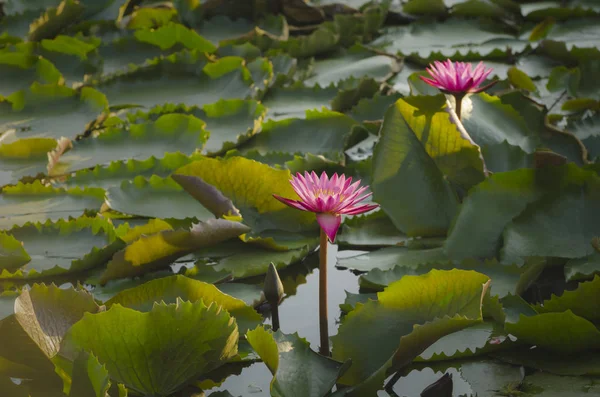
[105, 276, 262, 335]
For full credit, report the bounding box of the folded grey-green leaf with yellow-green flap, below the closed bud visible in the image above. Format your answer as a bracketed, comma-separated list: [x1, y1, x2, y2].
[246, 327, 349, 397]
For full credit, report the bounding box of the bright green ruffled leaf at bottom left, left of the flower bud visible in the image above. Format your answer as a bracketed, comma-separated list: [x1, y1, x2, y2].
[69, 300, 238, 396]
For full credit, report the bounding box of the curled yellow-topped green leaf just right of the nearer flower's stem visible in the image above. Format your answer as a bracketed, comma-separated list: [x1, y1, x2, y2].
[332, 270, 489, 395]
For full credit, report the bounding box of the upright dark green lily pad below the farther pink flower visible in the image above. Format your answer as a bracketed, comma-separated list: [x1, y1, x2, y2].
[371, 99, 468, 236]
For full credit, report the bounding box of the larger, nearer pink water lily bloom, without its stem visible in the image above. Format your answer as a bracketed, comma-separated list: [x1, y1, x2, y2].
[273, 171, 379, 243]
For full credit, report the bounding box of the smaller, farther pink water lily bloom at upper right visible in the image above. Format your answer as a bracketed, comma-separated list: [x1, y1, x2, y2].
[419, 59, 496, 95]
